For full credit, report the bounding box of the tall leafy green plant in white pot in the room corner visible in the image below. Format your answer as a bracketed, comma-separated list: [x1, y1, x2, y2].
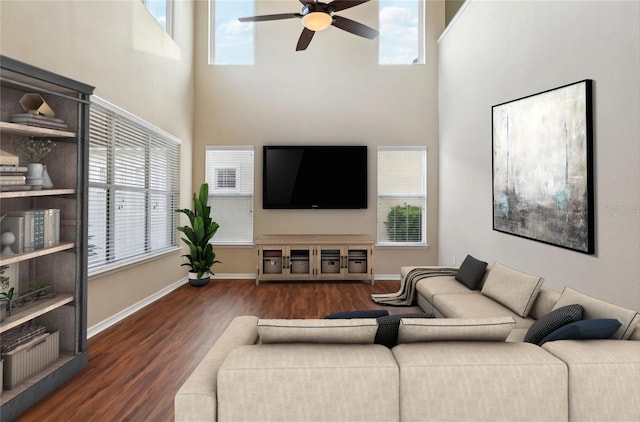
[176, 183, 220, 287]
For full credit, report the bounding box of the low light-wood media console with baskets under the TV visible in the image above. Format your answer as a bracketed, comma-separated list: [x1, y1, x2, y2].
[255, 234, 375, 285]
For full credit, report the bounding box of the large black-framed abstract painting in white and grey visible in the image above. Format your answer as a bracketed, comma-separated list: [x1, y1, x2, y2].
[491, 79, 595, 254]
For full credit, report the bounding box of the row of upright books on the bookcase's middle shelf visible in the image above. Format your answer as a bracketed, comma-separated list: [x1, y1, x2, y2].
[0, 208, 60, 253]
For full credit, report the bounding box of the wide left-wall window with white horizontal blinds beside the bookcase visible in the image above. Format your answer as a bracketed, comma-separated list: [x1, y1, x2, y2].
[88, 97, 180, 273]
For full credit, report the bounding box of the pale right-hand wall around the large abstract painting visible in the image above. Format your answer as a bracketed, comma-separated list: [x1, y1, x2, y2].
[439, 0, 640, 309]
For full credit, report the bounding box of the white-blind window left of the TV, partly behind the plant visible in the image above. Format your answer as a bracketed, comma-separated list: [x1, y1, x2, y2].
[206, 146, 253, 245]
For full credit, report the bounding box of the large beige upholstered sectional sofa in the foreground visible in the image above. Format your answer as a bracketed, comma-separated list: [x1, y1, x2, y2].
[175, 264, 640, 422]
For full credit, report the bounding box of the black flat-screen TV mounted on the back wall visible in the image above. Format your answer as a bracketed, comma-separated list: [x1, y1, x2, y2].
[262, 146, 367, 209]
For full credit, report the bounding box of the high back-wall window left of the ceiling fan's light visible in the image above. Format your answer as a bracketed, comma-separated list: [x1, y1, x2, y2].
[214, 0, 254, 65]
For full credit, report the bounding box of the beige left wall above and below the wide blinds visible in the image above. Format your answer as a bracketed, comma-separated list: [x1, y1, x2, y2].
[0, 0, 193, 327]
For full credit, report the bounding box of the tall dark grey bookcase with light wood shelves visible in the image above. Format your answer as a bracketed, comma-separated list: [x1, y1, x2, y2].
[0, 56, 94, 422]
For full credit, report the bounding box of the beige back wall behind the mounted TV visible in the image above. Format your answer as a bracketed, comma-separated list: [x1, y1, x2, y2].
[193, 0, 444, 275]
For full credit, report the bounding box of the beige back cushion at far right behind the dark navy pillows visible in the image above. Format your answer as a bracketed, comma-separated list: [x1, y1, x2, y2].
[554, 287, 640, 340]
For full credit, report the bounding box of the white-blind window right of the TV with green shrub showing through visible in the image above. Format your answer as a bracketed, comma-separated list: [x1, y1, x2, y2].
[377, 147, 427, 246]
